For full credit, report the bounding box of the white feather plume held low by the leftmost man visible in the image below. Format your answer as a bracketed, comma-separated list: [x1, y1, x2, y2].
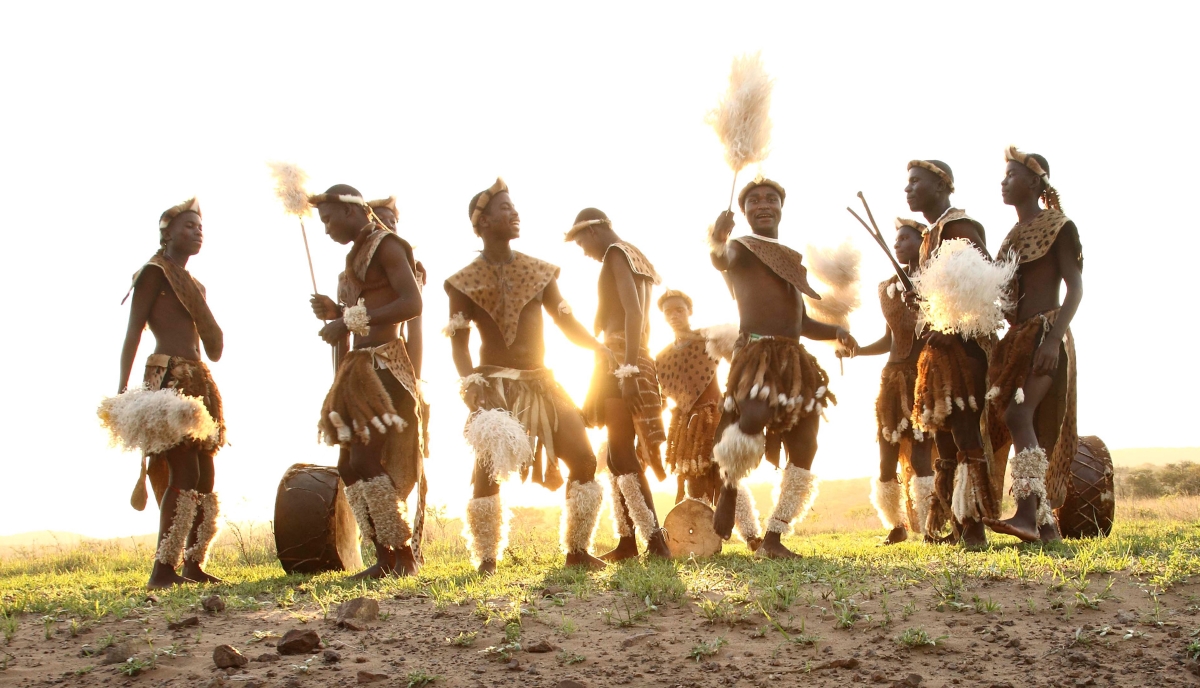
[96, 387, 218, 454]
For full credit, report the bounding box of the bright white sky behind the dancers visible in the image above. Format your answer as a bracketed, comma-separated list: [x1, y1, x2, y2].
[0, 2, 1200, 537]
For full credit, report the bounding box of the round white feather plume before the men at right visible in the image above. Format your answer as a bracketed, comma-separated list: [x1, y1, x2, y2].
[912, 239, 1016, 337]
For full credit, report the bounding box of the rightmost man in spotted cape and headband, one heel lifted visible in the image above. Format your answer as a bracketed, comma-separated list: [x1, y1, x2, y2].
[986, 146, 1084, 542]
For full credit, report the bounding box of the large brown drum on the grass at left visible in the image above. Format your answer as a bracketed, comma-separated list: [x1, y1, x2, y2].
[275, 463, 362, 574]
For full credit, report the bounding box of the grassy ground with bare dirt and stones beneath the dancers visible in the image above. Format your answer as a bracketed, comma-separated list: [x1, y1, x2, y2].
[0, 489, 1200, 686]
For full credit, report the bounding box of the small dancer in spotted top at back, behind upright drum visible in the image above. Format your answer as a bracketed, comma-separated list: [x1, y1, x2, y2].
[654, 289, 762, 551]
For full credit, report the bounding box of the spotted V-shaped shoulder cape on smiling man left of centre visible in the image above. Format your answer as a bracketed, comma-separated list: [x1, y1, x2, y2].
[445, 251, 559, 346]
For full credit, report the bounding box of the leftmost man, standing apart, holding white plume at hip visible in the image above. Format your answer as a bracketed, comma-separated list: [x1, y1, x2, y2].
[116, 198, 224, 588]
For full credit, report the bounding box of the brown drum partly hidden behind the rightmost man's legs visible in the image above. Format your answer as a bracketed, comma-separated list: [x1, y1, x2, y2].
[1055, 436, 1116, 538]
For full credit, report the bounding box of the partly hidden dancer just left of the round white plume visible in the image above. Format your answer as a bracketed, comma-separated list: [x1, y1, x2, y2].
[857, 217, 934, 545]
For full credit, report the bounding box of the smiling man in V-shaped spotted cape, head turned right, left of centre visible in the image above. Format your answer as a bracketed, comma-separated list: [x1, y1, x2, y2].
[445, 179, 611, 575]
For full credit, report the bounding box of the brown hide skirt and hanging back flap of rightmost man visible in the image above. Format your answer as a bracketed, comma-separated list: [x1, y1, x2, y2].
[989, 309, 1079, 509]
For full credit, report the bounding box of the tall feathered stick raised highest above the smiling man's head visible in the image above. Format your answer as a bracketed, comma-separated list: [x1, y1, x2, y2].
[704, 53, 775, 210]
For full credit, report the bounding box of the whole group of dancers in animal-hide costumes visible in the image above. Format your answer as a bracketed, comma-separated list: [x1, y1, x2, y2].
[112, 148, 1082, 587]
